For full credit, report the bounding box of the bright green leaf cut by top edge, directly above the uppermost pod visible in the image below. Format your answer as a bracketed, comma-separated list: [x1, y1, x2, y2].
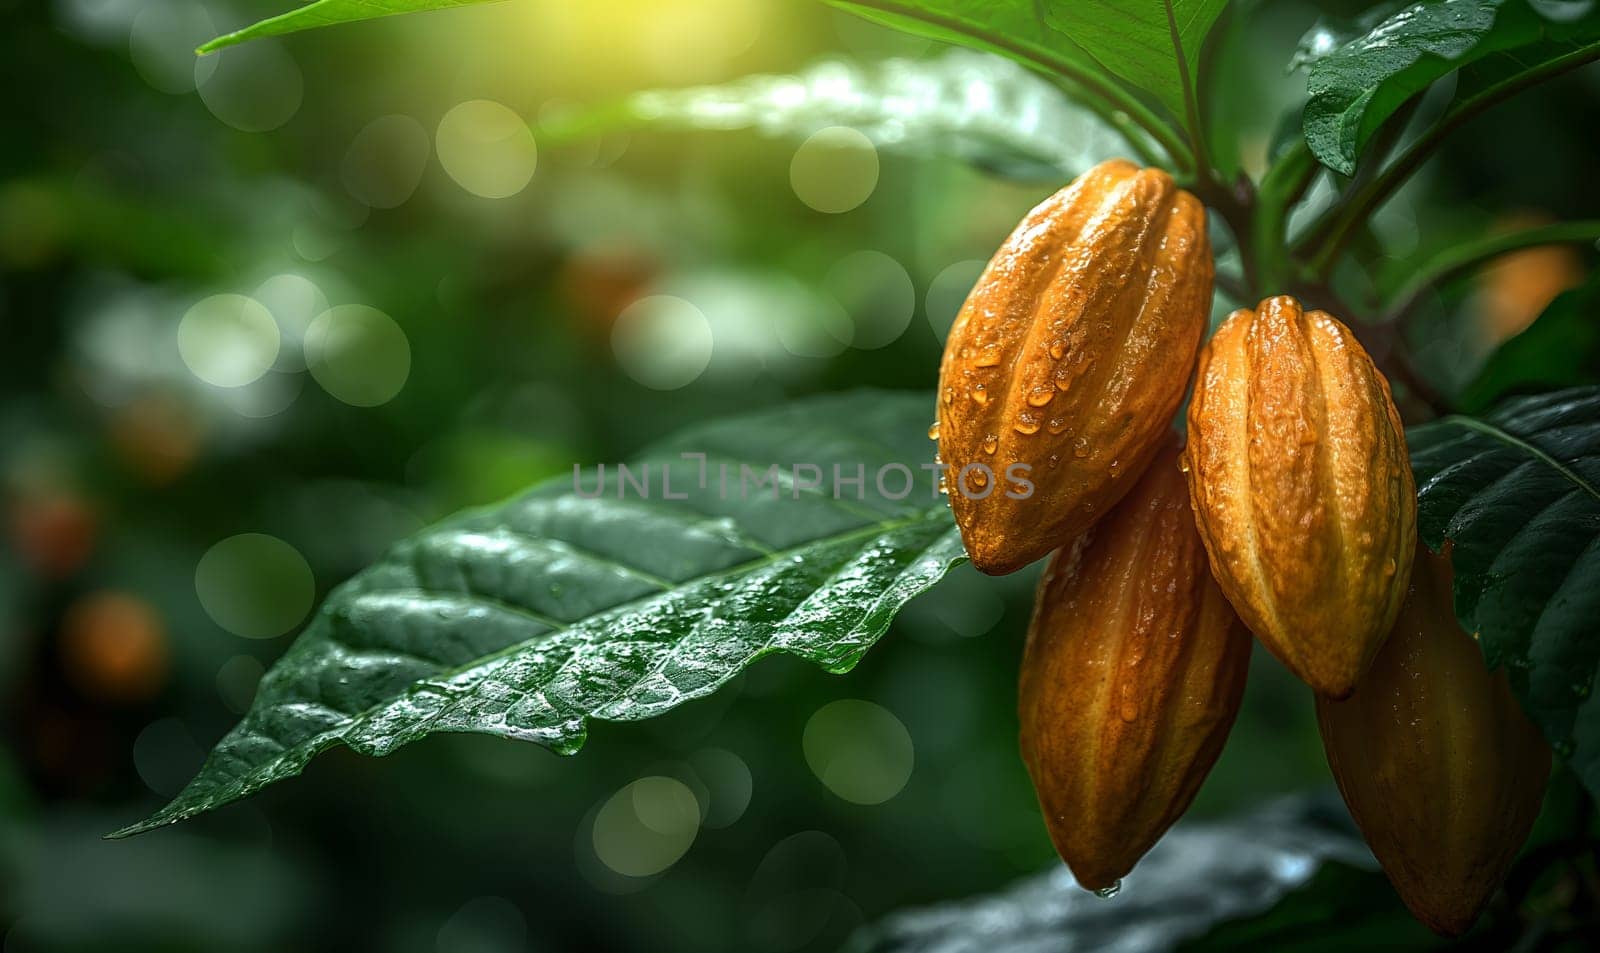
[1045, 0, 1227, 117]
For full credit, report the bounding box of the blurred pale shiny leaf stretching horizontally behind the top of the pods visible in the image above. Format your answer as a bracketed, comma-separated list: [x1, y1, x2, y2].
[544, 50, 1130, 182]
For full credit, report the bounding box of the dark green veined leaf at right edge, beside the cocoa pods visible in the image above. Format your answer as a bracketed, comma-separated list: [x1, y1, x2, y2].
[1406, 387, 1600, 793]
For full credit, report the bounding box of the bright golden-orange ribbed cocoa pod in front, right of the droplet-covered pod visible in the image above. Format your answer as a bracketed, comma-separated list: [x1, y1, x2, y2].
[1186, 296, 1416, 697]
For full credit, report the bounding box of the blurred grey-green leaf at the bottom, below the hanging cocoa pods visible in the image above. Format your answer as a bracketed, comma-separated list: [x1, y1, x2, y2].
[845, 798, 1394, 953]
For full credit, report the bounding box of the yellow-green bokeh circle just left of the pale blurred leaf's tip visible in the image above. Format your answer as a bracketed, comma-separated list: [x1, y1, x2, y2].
[435, 99, 539, 198]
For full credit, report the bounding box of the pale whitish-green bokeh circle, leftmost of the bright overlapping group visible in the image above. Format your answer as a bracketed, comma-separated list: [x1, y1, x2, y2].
[178, 294, 282, 387]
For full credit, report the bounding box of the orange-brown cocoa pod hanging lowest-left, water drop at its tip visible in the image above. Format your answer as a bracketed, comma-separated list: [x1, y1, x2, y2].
[1019, 448, 1251, 889]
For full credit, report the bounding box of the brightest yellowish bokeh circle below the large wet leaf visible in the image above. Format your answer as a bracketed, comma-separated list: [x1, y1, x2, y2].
[594, 776, 701, 876]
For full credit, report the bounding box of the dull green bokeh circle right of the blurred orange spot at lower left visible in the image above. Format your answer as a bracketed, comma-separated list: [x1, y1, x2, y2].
[195, 532, 317, 638]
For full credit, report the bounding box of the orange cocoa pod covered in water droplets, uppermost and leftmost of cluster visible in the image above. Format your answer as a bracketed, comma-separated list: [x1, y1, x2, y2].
[938, 160, 1211, 574]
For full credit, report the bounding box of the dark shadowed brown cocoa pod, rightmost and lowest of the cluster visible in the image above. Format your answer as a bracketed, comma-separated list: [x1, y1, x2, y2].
[1317, 550, 1550, 937]
